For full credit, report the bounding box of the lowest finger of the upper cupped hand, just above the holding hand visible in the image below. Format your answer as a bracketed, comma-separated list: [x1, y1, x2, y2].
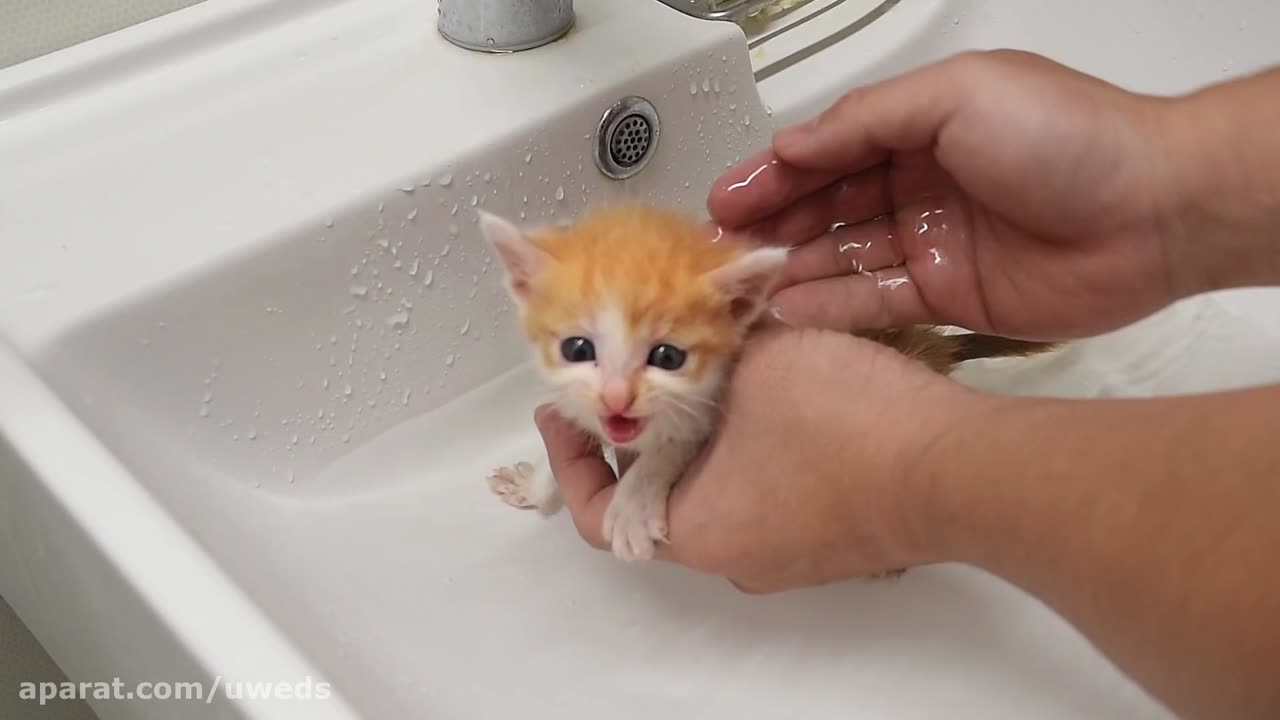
[773, 268, 934, 332]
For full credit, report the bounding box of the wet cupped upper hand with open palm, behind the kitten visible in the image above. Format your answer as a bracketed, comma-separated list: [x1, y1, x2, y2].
[708, 51, 1194, 340]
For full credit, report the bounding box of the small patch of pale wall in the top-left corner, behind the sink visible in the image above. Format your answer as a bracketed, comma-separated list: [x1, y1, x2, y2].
[0, 0, 202, 68]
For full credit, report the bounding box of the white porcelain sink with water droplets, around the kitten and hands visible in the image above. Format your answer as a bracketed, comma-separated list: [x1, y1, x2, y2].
[0, 0, 1280, 719]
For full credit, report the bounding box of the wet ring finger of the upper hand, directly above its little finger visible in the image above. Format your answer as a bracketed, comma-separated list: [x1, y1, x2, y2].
[777, 217, 904, 290]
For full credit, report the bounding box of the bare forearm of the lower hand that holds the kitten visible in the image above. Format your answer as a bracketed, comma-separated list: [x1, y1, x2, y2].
[922, 387, 1280, 719]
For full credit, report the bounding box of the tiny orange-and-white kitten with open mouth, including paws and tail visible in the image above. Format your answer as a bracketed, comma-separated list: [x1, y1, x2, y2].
[480, 206, 1048, 561]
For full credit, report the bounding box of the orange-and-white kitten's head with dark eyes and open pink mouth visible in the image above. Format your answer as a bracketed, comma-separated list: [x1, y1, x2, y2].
[480, 206, 786, 447]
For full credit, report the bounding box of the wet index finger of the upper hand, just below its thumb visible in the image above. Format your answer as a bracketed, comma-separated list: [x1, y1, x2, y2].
[707, 150, 846, 229]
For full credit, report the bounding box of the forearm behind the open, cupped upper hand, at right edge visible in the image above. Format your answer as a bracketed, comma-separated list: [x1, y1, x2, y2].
[1161, 68, 1280, 295]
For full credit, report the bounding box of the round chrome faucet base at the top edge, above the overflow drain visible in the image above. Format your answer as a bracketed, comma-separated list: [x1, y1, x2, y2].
[436, 0, 573, 53]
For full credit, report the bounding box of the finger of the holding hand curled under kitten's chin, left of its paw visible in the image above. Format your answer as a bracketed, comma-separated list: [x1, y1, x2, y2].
[534, 405, 617, 548]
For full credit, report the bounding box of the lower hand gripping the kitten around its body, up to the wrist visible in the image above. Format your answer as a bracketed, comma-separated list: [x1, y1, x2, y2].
[536, 329, 978, 592]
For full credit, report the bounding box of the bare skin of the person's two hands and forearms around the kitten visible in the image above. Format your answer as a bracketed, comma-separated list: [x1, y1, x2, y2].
[538, 53, 1280, 719]
